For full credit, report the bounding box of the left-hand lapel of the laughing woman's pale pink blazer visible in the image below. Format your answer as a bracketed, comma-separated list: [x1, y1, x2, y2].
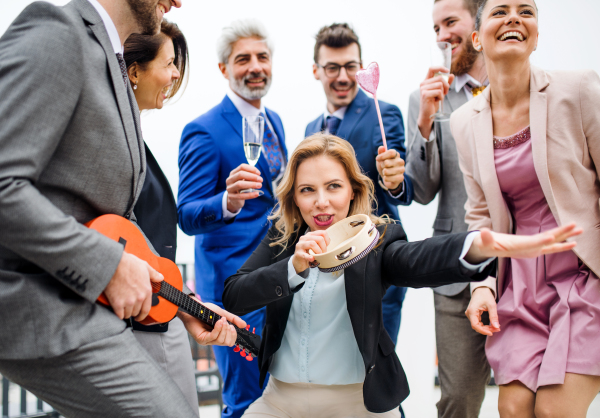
[471, 89, 510, 233]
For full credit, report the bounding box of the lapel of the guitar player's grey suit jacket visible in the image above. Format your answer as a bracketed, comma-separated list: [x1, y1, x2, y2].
[75, 0, 145, 194]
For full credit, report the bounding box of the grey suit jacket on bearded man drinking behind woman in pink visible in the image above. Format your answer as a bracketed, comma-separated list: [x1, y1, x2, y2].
[406, 86, 467, 296]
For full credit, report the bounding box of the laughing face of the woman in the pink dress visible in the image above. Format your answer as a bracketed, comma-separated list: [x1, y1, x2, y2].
[473, 0, 538, 62]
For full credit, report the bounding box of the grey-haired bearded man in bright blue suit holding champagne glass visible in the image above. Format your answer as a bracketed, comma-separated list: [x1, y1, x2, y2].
[178, 20, 287, 418]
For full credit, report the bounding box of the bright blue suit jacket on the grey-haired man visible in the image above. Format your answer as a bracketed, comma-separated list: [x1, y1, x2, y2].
[178, 96, 287, 304]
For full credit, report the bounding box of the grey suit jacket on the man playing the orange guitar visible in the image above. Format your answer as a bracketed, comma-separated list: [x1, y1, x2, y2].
[0, 0, 145, 359]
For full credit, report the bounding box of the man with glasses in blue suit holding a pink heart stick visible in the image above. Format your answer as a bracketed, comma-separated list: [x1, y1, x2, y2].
[305, 23, 413, 350]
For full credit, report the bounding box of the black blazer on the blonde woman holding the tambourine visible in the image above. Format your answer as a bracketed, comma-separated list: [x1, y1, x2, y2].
[223, 224, 496, 413]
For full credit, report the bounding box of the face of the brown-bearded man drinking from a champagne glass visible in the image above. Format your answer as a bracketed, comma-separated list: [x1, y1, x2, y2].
[433, 0, 478, 75]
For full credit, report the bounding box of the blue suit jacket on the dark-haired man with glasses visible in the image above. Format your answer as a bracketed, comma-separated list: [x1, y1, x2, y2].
[305, 89, 413, 220]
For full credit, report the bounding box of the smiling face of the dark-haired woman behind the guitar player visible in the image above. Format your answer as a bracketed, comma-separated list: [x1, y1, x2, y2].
[133, 35, 180, 110]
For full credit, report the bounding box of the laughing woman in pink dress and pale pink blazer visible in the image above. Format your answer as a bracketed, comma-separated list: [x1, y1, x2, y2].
[451, 0, 600, 418]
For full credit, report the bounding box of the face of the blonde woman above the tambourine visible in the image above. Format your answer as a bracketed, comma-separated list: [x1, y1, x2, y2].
[294, 155, 354, 231]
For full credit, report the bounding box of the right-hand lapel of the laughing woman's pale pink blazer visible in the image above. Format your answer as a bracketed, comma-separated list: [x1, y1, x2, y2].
[529, 67, 560, 224]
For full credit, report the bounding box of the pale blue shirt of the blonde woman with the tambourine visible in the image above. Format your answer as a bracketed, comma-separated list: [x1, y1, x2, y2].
[269, 230, 494, 385]
